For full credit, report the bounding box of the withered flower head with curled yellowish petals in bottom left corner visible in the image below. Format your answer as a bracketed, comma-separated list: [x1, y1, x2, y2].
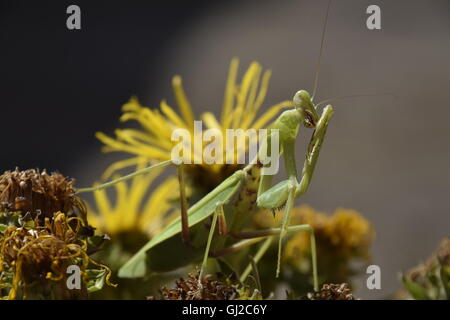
[0, 212, 115, 299]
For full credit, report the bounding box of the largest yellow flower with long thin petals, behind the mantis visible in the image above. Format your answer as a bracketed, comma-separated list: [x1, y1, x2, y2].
[96, 58, 293, 188]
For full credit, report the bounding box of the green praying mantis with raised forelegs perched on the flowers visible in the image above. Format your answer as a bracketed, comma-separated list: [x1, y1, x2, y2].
[77, 0, 333, 290]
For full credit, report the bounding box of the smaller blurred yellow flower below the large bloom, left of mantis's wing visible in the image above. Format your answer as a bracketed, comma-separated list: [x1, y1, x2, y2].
[89, 158, 179, 237]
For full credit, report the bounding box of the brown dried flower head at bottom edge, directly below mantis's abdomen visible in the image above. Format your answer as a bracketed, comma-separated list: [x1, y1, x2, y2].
[147, 273, 239, 300]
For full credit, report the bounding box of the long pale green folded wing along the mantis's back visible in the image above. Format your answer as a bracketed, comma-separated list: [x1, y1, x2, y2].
[119, 171, 244, 278]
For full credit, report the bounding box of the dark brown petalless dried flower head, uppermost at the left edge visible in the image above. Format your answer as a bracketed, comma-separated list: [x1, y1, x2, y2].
[0, 169, 86, 223]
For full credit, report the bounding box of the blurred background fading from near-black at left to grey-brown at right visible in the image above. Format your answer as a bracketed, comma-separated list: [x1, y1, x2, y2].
[0, 0, 450, 298]
